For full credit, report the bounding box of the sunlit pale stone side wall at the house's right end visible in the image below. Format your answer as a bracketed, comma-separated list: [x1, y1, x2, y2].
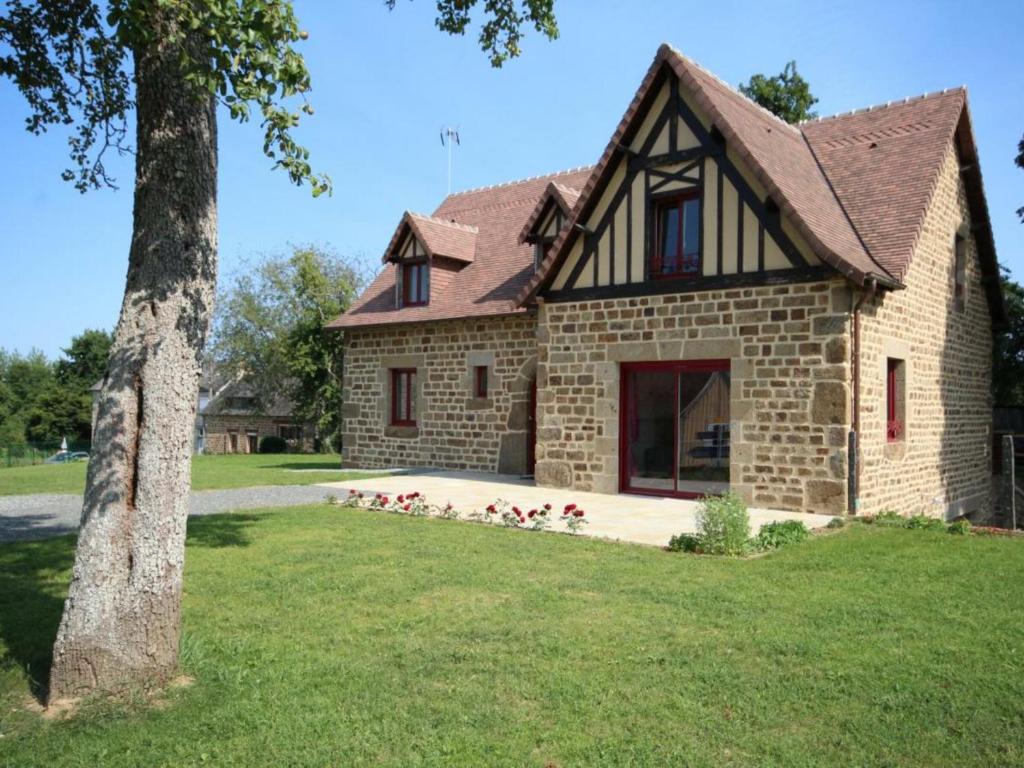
[860, 146, 992, 517]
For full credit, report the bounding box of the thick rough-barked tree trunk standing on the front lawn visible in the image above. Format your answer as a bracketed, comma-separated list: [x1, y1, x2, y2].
[49, 19, 217, 702]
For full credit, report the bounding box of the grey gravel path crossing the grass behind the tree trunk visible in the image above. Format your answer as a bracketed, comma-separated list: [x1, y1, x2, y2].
[0, 485, 340, 542]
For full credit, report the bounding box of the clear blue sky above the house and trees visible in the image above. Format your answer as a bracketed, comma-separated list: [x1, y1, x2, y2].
[0, 0, 1024, 355]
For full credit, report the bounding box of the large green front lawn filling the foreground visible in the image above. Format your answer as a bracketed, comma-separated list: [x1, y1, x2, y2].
[0, 506, 1024, 768]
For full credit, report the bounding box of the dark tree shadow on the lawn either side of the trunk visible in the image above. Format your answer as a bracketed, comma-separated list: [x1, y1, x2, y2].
[0, 514, 266, 701]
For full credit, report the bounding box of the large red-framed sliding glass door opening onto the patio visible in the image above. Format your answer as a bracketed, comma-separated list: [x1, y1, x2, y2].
[620, 360, 731, 499]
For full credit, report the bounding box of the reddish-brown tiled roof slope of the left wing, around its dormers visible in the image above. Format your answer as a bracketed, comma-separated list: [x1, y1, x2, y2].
[327, 168, 591, 329]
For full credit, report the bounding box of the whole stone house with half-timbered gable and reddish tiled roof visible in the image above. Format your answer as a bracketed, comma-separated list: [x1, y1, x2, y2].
[329, 45, 1005, 517]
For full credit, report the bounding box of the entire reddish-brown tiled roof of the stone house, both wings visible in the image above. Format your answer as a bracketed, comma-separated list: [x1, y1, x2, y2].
[330, 45, 1005, 328]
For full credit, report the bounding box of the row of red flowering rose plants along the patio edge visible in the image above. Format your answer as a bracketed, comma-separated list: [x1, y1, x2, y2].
[327, 489, 588, 534]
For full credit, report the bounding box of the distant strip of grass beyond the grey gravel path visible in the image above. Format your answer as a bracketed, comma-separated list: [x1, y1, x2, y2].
[0, 454, 373, 496]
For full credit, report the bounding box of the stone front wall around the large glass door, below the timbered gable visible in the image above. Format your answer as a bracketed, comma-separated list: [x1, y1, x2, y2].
[537, 280, 851, 514]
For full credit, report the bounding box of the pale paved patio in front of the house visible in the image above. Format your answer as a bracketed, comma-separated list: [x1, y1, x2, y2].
[318, 471, 831, 547]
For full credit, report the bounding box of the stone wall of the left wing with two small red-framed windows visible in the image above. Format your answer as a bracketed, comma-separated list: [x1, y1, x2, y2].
[342, 313, 537, 474]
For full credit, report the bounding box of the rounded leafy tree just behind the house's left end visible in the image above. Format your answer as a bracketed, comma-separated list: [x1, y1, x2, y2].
[210, 246, 365, 446]
